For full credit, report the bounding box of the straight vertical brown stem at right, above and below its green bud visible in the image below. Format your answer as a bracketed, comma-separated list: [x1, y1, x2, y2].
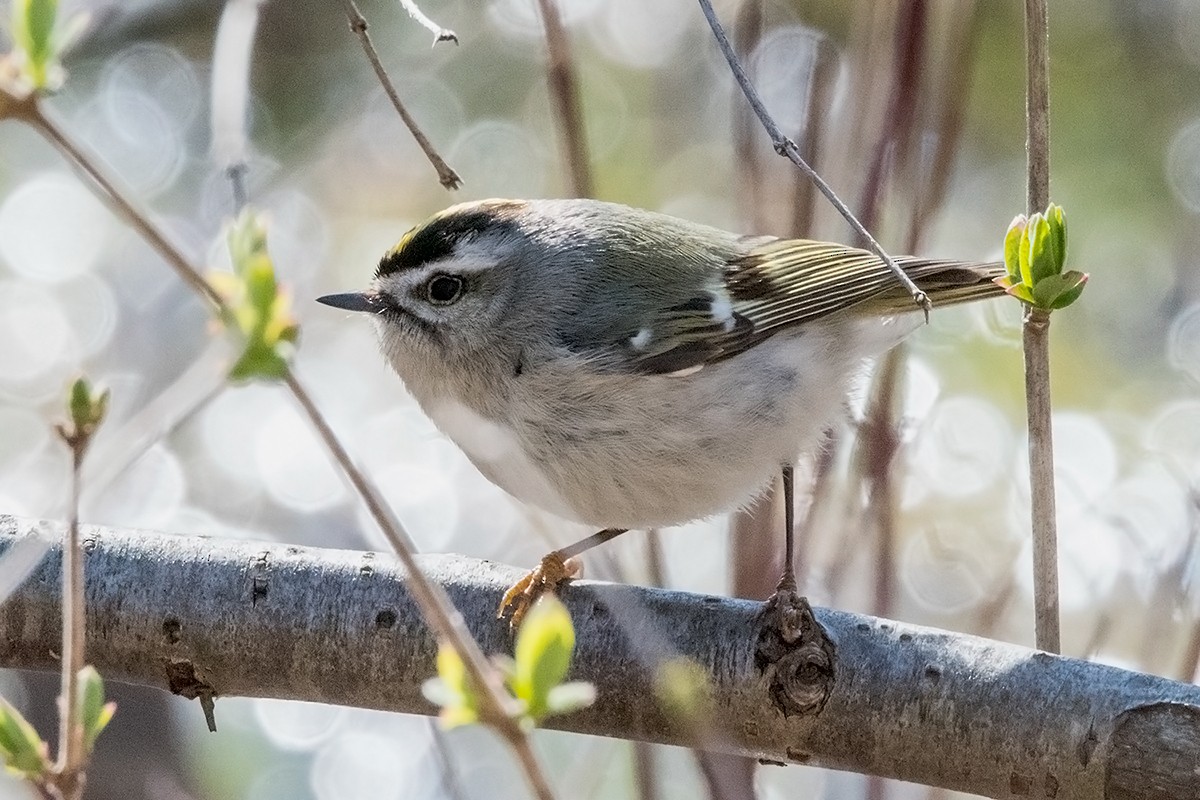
[1021, 0, 1061, 652]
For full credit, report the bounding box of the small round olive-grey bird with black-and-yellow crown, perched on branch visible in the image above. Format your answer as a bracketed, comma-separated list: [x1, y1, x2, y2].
[320, 200, 1004, 615]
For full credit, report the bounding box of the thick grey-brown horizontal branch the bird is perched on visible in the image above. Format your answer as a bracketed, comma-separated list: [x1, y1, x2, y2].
[0, 516, 1200, 800]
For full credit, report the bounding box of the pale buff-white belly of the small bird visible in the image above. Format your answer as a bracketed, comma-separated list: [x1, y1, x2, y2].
[489, 331, 857, 528]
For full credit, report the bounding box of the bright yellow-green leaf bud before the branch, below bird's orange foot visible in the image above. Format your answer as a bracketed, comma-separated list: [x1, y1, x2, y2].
[511, 595, 575, 720]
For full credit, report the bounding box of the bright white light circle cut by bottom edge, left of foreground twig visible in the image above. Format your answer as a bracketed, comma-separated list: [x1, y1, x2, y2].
[310, 730, 438, 800]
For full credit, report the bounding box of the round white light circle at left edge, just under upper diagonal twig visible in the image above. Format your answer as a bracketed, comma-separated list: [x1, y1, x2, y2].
[0, 172, 112, 282]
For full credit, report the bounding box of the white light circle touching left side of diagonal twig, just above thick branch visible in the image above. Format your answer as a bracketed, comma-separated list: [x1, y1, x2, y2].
[254, 407, 346, 512]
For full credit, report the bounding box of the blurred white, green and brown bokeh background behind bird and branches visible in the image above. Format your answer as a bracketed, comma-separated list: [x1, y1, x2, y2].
[0, 0, 1200, 800]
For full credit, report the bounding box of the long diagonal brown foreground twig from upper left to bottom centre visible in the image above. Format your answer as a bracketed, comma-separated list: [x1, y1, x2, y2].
[29, 98, 553, 800]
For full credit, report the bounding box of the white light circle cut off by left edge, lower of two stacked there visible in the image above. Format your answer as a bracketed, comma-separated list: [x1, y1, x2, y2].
[0, 281, 73, 387]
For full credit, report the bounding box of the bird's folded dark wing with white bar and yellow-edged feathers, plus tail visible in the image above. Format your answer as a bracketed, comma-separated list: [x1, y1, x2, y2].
[622, 239, 1004, 374]
